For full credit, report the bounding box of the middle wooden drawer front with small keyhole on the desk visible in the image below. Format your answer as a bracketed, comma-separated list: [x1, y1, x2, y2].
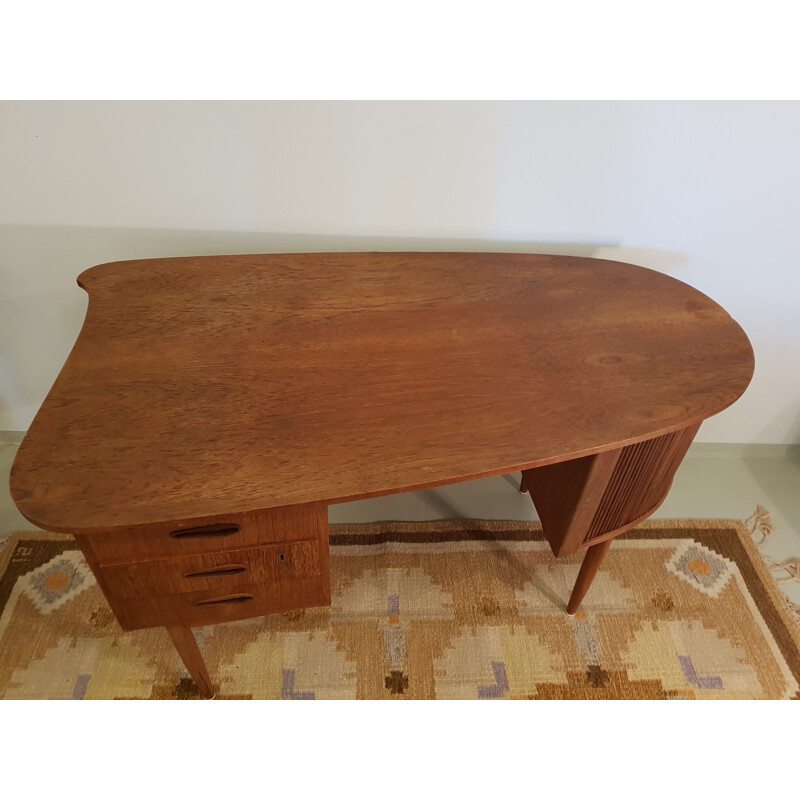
[100, 541, 319, 598]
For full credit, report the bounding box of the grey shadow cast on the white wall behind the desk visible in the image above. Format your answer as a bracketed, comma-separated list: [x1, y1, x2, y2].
[0, 225, 687, 430]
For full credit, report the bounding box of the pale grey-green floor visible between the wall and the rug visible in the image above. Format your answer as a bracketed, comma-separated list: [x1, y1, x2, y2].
[0, 439, 800, 603]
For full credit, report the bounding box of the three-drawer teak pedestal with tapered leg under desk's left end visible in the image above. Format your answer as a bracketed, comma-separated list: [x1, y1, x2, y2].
[75, 504, 331, 697]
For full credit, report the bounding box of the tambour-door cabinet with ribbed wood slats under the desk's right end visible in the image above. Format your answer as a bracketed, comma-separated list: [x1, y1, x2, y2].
[523, 425, 699, 556]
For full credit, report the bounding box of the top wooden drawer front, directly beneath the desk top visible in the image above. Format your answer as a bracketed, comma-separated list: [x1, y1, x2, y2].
[87, 505, 328, 566]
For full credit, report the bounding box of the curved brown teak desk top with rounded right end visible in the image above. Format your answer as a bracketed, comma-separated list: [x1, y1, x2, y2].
[11, 253, 753, 533]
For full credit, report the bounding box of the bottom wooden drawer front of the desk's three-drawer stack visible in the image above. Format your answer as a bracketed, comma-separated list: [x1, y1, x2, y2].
[108, 575, 330, 630]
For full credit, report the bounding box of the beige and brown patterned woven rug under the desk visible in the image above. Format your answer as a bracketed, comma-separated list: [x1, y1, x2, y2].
[0, 521, 800, 699]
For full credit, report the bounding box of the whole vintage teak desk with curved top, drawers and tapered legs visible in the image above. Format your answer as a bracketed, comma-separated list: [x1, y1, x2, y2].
[11, 253, 753, 694]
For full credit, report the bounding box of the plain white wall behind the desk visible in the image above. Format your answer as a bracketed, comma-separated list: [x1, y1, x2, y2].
[0, 102, 800, 443]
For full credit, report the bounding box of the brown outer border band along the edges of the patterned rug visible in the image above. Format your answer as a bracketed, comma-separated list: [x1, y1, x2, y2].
[0, 519, 800, 649]
